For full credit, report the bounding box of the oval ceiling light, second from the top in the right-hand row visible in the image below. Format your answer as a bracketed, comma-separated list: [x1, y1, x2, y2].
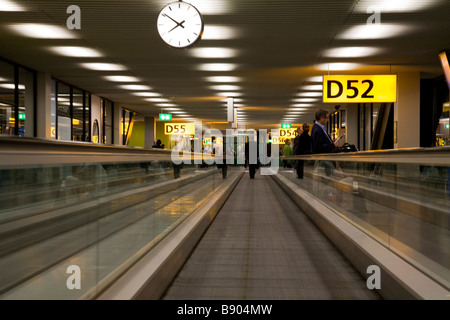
[336, 23, 414, 40]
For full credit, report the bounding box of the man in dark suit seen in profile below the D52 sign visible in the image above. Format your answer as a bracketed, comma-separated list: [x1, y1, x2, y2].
[311, 109, 338, 176]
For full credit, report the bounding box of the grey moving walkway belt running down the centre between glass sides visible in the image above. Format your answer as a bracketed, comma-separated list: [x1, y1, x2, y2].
[163, 173, 381, 300]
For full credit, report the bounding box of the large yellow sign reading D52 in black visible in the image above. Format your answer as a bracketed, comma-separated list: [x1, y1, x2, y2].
[323, 75, 397, 103]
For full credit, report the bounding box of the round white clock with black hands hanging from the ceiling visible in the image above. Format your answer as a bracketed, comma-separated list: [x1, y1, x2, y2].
[157, 1, 203, 48]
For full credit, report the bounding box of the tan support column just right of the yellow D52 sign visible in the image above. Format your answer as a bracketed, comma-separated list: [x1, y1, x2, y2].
[394, 72, 420, 149]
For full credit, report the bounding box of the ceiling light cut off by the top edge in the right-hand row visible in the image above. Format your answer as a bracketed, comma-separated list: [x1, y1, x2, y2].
[356, 0, 442, 13]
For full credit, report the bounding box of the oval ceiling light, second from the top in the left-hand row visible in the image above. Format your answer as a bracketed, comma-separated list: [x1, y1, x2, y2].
[7, 23, 77, 39]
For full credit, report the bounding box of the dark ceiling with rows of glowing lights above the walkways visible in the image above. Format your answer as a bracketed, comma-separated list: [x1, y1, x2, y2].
[0, 0, 450, 129]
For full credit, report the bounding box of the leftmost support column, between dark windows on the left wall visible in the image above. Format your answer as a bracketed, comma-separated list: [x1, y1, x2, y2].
[36, 72, 52, 139]
